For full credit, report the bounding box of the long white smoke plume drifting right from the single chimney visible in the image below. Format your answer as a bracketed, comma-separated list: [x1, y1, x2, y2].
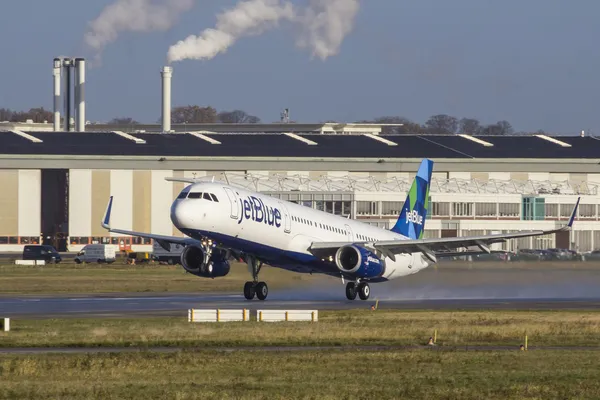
[167, 0, 359, 63]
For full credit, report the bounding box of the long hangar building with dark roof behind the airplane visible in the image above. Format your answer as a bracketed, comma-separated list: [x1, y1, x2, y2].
[0, 124, 600, 251]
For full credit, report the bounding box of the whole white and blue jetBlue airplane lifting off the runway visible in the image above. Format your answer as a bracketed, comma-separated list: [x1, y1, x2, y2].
[102, 159, 579, 300]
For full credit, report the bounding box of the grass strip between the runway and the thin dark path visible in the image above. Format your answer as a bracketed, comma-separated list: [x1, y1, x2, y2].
[0, 310, 600, 348]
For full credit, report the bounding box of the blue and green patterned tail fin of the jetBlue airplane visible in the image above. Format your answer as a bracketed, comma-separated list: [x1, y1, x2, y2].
[391, 159, 433, 239]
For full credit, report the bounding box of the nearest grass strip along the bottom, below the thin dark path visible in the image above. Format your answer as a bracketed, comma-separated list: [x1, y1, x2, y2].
[0, 349, 600, 400]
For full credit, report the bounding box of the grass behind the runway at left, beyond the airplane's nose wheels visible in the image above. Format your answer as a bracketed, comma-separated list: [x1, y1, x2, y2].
[0, 263, 314, 295]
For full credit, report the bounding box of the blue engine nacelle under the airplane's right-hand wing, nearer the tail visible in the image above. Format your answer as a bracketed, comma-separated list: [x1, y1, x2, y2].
[335, 245, 385, 279]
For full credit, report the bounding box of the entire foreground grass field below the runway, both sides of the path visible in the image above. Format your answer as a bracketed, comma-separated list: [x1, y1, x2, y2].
[0, 309, 600, 399]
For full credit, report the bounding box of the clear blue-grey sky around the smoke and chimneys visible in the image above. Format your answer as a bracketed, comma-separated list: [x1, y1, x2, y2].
[0, 0, 600, 134]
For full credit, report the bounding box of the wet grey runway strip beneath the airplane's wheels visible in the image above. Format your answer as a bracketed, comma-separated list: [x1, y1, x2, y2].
[0, 294, 600, 318]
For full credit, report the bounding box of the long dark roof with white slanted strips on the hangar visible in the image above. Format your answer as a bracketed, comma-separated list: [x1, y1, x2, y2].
[0, 131, 600, 159]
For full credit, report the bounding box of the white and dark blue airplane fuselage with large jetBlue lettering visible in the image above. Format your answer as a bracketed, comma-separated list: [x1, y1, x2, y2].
[171, 183, 430, 282]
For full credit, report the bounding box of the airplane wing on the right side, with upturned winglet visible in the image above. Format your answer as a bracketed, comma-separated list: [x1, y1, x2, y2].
[309, 199, 580, 262]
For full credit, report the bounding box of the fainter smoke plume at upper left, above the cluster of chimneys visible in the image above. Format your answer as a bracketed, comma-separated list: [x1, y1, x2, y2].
[84, 0, 194, 55]
